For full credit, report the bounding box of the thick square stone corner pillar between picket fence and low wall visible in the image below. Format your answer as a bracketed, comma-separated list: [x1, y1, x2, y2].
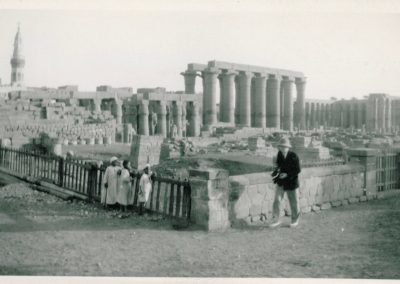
[189, 169, 230, 231]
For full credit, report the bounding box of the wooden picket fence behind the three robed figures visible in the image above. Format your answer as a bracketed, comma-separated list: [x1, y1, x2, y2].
[0, 147, 191, 220]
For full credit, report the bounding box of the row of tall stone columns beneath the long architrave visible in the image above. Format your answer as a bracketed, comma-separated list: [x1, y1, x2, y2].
[182, 67, 305, 130]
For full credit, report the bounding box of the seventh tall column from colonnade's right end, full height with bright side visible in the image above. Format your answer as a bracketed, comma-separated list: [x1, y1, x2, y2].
[203, 67, 219, 125]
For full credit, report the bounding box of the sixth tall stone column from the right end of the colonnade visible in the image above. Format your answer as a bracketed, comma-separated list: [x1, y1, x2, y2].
[220, 70, 237, 123]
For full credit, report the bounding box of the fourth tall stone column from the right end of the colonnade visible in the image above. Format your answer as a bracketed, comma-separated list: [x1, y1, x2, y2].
[253, 74, 267, 128]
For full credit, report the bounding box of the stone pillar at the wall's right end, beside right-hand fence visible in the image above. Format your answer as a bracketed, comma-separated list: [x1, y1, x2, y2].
[347, 148, 379, 196]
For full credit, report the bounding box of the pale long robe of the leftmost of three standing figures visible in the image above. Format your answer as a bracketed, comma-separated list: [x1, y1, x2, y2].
[101, 166, 121, 204]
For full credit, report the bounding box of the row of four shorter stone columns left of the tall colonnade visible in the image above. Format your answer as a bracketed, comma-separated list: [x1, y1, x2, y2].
[138, 100, 200, 137]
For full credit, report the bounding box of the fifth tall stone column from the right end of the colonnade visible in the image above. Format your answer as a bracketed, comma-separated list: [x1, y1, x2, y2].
[239, 72, 253, 127]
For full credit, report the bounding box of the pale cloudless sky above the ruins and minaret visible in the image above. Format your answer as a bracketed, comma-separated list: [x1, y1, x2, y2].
[0, 0, 400, 99]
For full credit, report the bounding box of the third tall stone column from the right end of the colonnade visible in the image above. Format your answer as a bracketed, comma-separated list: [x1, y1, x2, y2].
[267, 75, 281, 129]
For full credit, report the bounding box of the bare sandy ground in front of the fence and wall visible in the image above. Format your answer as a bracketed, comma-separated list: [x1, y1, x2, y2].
[0, 181, 400, 279]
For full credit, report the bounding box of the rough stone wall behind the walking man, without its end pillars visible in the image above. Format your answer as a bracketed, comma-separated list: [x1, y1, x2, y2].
[228, 164, 368, 226]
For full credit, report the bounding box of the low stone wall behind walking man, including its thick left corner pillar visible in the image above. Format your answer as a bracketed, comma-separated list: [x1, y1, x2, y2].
[189, 161, 377, 231]
